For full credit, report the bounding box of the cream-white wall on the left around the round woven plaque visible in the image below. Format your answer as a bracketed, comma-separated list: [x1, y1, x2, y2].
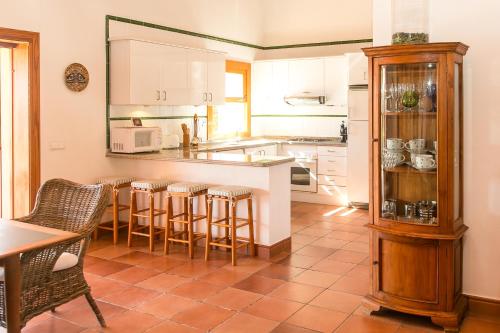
[0, 0, 262, 182]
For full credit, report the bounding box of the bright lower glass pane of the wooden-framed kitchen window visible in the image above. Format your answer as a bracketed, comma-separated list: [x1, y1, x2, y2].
[213, 102, 247, 137]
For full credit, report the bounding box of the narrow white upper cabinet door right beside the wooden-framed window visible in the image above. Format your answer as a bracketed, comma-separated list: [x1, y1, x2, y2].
[206, 51, 226, 105]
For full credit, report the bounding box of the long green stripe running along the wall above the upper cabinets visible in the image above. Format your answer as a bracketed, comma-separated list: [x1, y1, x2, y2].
[106, 15, 373, 50]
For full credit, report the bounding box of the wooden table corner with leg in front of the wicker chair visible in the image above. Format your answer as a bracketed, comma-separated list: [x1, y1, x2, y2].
[0, 219, 79, 333]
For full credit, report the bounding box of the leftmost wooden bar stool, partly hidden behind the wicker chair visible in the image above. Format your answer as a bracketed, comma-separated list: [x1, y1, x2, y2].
[94, 176, 135, 245]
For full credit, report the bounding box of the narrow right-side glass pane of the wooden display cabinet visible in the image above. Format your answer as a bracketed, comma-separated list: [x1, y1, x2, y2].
[453, 64, 462, 220]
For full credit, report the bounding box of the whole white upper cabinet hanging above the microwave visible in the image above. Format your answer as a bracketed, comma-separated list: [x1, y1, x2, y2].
[110, 40, 225, 105]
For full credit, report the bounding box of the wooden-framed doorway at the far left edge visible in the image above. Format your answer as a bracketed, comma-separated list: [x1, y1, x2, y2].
[0, 28, 40, 219]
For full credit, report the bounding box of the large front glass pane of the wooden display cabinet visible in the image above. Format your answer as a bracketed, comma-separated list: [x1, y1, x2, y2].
[380, 63, 439, 225]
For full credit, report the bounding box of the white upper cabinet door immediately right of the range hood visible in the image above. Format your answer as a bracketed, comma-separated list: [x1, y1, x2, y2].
[325, 56, 348, 107]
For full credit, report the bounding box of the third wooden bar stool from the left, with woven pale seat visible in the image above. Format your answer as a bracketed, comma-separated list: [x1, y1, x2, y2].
[164, 183, 208, 259]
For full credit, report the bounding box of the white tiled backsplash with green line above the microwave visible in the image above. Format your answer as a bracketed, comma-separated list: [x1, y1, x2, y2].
[110, 105, 207, 141]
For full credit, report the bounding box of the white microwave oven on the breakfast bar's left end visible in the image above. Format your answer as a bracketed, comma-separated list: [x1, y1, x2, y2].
[111, 127, 161, 154]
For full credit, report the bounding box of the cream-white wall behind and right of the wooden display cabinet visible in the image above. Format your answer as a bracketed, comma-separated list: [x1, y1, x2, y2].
[373, 0, 500, 299]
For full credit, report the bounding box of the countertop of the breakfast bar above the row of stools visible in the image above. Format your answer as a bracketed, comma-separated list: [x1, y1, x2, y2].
[106, 148, 295, 167]
